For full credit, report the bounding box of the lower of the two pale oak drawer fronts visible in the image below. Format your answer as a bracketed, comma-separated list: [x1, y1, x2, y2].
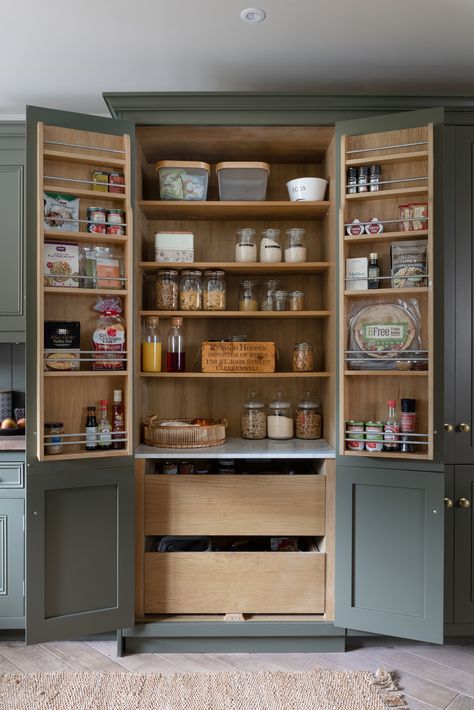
[145, 552, 326, 614]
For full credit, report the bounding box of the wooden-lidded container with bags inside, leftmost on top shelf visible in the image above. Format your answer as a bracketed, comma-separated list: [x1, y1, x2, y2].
[156, 160, 210, 200]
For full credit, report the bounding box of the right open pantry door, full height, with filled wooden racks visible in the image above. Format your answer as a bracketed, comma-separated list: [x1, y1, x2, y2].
[335, 109, 444, 643]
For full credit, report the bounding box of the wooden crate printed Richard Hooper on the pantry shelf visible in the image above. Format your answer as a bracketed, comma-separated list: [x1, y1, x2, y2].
[201, 341, 275, 373]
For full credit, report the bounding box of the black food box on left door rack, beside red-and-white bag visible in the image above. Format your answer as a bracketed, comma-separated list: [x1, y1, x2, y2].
[44, 320, 81, 370]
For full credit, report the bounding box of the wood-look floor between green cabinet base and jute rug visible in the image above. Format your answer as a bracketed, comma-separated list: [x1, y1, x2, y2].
[0, 639, 474, 710]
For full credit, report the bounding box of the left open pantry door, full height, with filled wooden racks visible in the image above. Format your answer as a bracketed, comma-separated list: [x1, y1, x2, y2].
[26, 107, 134, 643]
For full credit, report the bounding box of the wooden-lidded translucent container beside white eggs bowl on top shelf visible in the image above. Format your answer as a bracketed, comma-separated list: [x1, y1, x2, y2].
[216, 162, 270, 201]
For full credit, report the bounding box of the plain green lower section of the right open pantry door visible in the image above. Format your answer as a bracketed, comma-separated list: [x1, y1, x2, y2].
[336, 462, 444, 643]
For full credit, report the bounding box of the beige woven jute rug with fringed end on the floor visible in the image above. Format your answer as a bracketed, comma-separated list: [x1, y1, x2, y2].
[0, 669, 407, 710]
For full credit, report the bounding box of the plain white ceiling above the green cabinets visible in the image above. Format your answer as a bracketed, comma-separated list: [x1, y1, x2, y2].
[0, 0, 474, 118]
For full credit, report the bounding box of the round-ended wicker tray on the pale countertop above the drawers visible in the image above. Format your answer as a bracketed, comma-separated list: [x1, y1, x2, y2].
[143, 414, 227, 449]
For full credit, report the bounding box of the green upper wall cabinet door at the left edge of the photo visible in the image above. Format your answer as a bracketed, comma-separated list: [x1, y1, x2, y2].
[0, 122, 26, 343]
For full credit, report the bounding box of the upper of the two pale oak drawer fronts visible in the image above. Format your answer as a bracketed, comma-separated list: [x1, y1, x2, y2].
[145, 474, 326, 536]
